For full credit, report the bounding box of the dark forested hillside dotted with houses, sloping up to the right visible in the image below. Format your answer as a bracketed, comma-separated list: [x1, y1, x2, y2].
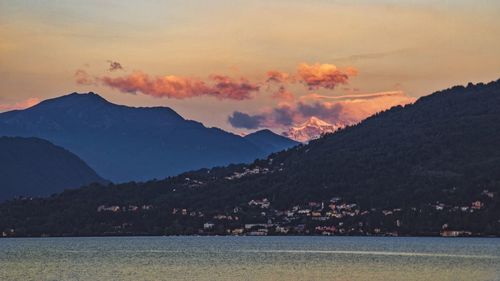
[0, 80, 500, 236]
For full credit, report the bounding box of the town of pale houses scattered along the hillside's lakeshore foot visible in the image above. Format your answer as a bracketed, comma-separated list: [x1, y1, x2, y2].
[2, 190, 490, 237]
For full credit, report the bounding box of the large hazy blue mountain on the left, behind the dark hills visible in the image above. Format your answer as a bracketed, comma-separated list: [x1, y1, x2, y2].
[0, 93, 296, 182]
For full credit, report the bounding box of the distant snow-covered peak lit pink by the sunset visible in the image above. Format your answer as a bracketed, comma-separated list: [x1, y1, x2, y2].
[283, 116, 344, 142]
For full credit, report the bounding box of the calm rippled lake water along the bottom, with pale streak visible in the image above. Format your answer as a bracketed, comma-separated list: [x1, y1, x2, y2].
[0, 237, 500, 281]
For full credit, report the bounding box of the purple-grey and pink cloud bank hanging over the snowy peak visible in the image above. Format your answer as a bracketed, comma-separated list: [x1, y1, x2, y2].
[230, 91, 415, 129]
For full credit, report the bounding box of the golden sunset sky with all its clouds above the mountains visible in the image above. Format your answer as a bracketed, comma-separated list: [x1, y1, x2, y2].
[0, 0, 500, 133]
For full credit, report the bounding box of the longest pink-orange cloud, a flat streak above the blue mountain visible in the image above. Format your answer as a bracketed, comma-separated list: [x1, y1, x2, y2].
[99, 71, 259, 100]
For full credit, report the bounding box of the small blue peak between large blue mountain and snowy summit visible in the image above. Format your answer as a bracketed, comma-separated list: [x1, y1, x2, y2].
[244, 129, 299, 154]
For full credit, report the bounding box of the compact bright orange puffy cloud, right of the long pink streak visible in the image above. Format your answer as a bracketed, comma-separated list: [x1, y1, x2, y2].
[297, 63, 357, 90]
